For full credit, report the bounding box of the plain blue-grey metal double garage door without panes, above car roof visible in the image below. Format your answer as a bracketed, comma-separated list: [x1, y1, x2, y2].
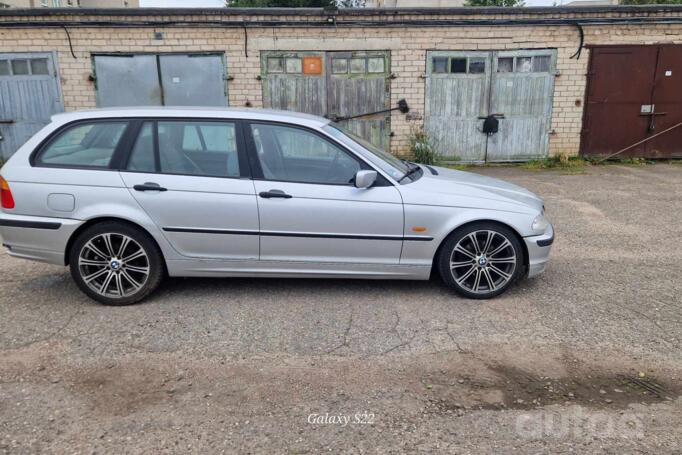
[93, 54, 227, 107]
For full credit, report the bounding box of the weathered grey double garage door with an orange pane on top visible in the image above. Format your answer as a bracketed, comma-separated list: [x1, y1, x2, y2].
[261, 51, 391, 150]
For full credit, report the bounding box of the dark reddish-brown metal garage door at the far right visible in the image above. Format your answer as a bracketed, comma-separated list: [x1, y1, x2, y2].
[581, 45, 682, 158]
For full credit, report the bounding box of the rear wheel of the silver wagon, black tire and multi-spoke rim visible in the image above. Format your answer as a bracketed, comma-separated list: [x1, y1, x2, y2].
[69, 221, 165, 306]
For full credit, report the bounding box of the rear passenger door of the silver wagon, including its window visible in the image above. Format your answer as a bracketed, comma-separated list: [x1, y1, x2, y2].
[121, 119, 258, 260]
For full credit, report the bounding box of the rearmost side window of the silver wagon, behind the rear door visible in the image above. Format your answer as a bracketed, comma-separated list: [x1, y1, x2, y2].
[36, 122, 128, 168]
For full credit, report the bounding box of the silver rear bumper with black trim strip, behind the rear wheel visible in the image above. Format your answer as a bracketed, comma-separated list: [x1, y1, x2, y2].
[0, 212, 83, 265]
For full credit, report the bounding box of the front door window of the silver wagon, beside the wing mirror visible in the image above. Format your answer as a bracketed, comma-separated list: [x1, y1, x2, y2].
[251, 124, 361, 185]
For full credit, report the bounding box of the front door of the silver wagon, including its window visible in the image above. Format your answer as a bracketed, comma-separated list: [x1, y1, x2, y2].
[244, 123, 403, 264]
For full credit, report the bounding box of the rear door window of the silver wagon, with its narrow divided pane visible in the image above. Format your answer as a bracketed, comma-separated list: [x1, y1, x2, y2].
[127, 121, 240, 177]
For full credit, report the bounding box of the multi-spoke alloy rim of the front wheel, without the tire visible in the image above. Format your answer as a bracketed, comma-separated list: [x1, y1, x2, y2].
[450, 230, 517, 294]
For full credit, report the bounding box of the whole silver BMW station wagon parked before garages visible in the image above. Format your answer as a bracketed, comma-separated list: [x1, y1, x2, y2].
[0, 108, 554, 305]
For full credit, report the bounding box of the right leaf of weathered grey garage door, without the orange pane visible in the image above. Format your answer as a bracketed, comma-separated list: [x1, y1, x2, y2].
[327, 52, 391, 150]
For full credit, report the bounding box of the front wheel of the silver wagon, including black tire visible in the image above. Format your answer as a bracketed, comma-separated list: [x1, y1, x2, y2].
[437, 222, 525, 299]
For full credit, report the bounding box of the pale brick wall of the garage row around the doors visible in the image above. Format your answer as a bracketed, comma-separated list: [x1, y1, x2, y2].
[0, 10, 682, 155]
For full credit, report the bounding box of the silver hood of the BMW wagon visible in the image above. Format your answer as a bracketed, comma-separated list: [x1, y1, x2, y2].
[401, 166, 543, 212]
